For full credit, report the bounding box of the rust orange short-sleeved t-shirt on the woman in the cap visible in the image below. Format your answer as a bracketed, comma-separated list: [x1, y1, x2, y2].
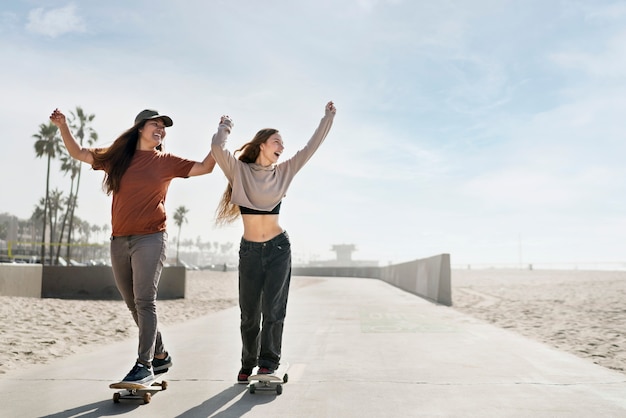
[94, 150, 195, 237]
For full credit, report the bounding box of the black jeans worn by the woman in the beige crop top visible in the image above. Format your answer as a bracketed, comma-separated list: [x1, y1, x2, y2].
[239, 232, 291, 369]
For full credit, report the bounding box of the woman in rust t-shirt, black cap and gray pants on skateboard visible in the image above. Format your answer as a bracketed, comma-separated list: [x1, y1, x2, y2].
[50, 109, 215, 385]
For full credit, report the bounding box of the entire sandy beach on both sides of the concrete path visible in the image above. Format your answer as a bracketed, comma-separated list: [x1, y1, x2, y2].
[0, 269, 626, 375]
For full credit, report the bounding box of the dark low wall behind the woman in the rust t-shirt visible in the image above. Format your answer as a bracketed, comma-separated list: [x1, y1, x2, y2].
[41, 266, 186, 300]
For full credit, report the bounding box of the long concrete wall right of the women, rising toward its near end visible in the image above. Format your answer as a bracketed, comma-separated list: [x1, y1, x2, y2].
[292, 254, 452, 306]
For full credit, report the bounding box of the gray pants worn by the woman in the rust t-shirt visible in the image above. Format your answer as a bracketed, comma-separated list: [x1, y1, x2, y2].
[111, 231, 167, 365]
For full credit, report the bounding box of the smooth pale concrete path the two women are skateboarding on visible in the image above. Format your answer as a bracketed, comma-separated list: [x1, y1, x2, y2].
[0, 278, 626, 418]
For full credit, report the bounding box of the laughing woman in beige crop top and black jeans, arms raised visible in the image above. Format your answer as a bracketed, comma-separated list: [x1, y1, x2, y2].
[211, 102, 336, 383]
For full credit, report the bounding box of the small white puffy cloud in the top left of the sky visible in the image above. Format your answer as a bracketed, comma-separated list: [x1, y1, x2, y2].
[26, 4, 86, 38]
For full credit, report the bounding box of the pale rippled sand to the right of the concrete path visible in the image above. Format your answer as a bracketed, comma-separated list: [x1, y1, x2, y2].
[452, 270, 626, 373]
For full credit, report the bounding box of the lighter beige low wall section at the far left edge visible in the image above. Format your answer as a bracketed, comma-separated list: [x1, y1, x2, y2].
[0, 263, 42, 298]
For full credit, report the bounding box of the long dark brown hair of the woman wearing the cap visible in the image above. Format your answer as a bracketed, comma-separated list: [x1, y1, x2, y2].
[92, 119, 163, 195]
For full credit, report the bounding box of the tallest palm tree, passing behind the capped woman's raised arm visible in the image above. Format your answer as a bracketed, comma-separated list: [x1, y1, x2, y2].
[61, 106, 98, 260]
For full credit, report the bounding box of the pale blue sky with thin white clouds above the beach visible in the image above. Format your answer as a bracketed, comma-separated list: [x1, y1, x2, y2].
[0, 0, 626, 266]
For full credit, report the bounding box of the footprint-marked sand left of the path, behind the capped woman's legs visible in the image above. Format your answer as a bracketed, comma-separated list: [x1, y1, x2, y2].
[0, 271, 237, 375]
